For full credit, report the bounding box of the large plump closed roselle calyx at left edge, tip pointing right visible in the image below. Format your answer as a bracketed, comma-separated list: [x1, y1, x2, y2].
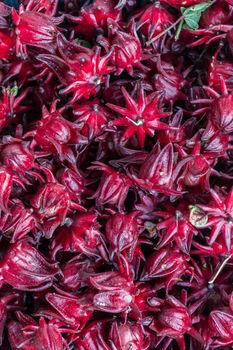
[0, 240, 59, 291]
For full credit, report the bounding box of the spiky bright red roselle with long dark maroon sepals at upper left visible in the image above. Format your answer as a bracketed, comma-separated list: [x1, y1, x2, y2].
[38, 35, 114, 103]
